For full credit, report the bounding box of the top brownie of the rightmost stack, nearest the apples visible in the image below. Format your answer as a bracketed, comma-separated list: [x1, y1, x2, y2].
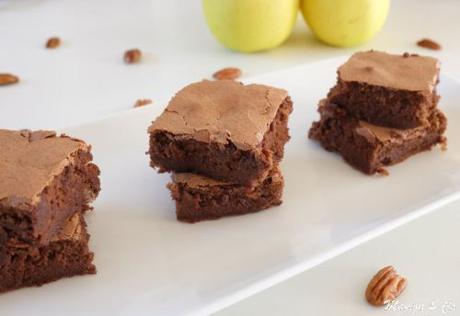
[328, 51, 440, 129]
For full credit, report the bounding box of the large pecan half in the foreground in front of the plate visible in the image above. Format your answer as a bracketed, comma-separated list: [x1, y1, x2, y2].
[366, 266, 407, 306]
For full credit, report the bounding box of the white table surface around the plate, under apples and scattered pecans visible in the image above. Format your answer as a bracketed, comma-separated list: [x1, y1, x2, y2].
[0, 0, 460, 315]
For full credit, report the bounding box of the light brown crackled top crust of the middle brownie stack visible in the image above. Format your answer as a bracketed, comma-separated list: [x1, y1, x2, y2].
[149, 80, 288, 150]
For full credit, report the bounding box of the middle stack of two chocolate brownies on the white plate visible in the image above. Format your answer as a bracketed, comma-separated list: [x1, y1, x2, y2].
[148, 80, 292, 222]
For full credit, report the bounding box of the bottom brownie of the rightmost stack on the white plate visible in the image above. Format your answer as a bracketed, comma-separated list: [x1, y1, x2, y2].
[309, 100, 447, 174]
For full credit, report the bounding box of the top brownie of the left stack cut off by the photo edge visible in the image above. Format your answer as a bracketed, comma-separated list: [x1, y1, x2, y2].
[0, 130, 100, 245]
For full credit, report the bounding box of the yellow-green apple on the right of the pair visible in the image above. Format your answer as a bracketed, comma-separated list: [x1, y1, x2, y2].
[300, 0, 390, 47]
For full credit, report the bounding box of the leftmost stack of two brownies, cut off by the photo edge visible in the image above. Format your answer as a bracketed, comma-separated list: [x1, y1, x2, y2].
[0, 130, 100, 292]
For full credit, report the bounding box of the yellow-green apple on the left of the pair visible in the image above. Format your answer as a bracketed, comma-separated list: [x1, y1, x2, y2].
[203, 0, 299, 52]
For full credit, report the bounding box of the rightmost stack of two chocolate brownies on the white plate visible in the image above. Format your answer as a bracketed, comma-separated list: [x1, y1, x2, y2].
[309, 51, 447, 174]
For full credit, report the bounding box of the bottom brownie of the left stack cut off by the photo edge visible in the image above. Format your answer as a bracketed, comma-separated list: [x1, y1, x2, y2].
[0, 213, 96, 292]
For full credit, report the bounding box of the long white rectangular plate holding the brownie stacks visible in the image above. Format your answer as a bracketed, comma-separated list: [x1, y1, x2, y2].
[0, 59, 460, 316]
